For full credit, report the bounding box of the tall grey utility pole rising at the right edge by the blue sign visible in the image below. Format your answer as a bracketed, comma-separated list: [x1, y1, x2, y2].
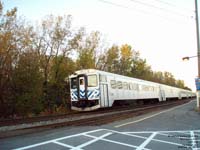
[195, 0, 200, 109]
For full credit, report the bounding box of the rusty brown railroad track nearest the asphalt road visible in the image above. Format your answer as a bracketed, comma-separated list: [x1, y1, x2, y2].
[0, 100, 190, 138]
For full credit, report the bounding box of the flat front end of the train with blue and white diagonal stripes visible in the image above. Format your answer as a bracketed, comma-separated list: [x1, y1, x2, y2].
[69, 69, 100, 111]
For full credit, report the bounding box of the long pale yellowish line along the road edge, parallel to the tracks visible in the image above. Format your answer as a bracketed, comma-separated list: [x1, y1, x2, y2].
[114, 101, 193, 128]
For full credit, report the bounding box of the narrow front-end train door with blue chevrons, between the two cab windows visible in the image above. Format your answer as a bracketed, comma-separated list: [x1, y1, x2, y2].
[78, 75, 87, 99]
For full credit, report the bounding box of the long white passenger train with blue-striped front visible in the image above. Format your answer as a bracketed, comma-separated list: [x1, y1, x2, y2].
[69, 69, 195, 111]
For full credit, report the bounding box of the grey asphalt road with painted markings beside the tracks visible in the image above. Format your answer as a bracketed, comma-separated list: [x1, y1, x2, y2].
[0, 101, 200, 150]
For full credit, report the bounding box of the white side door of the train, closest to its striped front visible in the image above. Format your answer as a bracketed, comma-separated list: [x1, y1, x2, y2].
[100, 84, 109, 107]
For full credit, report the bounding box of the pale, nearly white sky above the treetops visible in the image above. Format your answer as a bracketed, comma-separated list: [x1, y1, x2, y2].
[3, 0, 197, 91]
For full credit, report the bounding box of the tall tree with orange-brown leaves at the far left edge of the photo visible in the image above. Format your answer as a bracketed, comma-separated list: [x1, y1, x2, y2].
[0, 2, 32, 116]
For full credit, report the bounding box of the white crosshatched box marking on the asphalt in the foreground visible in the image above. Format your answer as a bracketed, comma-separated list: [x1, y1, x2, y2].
[16, 129, 200, 150]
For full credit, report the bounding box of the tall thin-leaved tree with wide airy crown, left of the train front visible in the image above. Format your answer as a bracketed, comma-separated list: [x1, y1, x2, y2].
[34, 15, 81, 112]
